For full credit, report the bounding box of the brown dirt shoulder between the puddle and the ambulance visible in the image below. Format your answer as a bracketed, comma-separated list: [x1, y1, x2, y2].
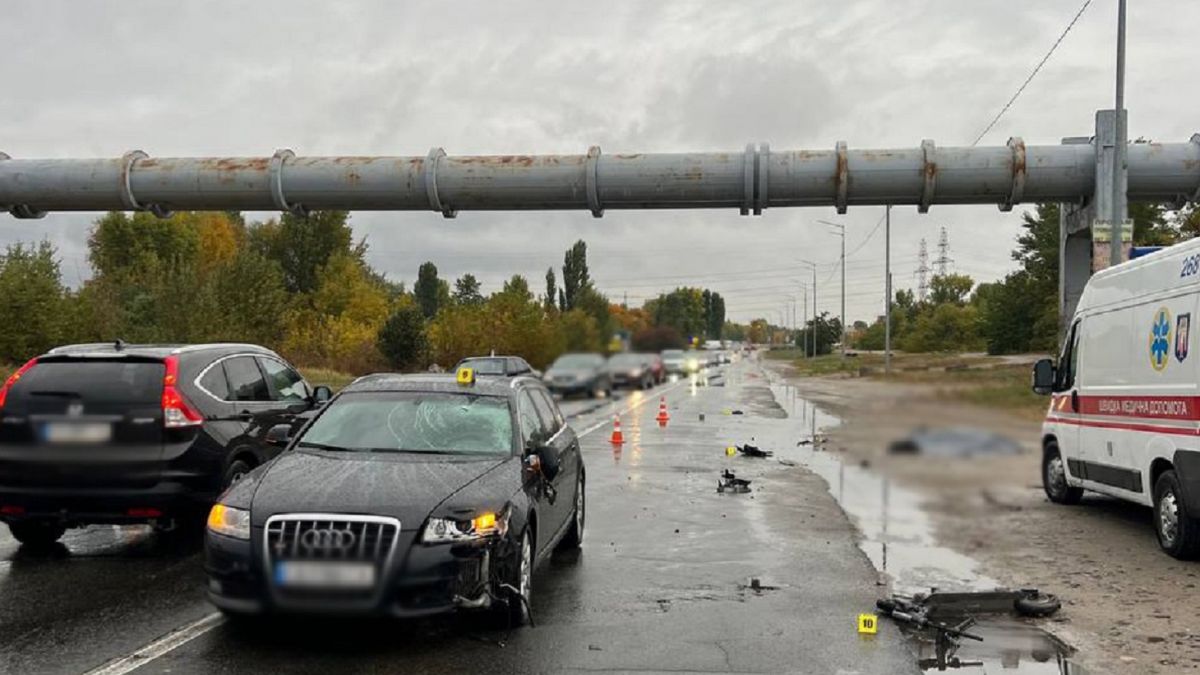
[764, 362, 1200, 674]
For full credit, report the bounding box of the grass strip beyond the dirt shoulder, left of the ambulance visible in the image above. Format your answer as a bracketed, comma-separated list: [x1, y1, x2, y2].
[768, 351, 1046, 419]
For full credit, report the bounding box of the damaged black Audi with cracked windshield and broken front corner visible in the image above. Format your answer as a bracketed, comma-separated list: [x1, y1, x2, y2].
[205, 365, 584, 626]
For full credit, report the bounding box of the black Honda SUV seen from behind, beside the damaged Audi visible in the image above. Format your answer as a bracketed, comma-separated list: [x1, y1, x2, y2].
[0, 342, 330, 545]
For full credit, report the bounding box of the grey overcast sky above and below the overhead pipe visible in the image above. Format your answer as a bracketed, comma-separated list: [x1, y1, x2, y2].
[0, 0, 1200, 322]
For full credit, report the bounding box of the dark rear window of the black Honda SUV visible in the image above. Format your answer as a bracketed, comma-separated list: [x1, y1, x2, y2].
[8, 359, 167, 404]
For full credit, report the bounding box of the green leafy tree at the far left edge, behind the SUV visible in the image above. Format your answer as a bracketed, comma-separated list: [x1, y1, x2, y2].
[0, 241, 67, 363]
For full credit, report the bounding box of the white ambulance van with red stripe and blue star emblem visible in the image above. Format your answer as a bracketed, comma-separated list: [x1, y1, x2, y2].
[1033, 239, 1200, 558]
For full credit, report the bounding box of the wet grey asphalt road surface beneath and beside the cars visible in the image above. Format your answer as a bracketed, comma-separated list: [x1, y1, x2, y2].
[0, 363, 916, 675]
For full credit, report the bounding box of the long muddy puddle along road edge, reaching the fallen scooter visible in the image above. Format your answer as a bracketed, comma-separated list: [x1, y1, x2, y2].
[748, 383, 1094, 675]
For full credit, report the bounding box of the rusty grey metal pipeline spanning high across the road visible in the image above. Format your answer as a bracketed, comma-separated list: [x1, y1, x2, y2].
[0, 135, 1200, 217]
